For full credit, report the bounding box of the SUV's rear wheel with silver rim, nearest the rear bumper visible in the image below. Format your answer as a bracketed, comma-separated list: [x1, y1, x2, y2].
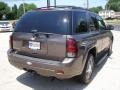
[78, 54, 94, 84]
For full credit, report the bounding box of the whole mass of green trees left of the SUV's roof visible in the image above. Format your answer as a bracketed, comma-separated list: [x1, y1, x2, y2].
[0, 2, 37, 20]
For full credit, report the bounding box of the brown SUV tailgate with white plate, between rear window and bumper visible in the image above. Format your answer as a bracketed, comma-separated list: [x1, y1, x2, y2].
[13, 32, 66, 60]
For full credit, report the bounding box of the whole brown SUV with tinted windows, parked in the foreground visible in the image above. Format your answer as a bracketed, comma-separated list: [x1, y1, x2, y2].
[8, 6, 113, 83]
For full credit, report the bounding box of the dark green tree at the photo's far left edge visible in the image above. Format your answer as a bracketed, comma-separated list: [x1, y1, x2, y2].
[0, 2, 10, 19]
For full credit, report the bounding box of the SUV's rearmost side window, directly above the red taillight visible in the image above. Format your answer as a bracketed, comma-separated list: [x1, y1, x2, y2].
[73, 12, 88, 33]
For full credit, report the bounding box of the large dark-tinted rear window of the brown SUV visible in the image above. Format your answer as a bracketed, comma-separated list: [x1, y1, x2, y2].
[14, 11, 70, 34]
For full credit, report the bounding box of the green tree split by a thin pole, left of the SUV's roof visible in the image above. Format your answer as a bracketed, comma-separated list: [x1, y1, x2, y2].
[18, 3, 37, 17]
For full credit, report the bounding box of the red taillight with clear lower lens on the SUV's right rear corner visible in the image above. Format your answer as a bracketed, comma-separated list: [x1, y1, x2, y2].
[66, 38, 78, 57]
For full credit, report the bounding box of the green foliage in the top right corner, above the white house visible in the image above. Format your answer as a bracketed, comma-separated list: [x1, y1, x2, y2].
[106, 0, 120, 11]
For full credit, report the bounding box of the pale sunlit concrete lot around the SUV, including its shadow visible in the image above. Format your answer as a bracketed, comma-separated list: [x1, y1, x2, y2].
[0, 31, 120, 90]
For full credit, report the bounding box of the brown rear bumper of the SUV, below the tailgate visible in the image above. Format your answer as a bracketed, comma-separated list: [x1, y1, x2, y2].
[8, 50, 81, 79]
